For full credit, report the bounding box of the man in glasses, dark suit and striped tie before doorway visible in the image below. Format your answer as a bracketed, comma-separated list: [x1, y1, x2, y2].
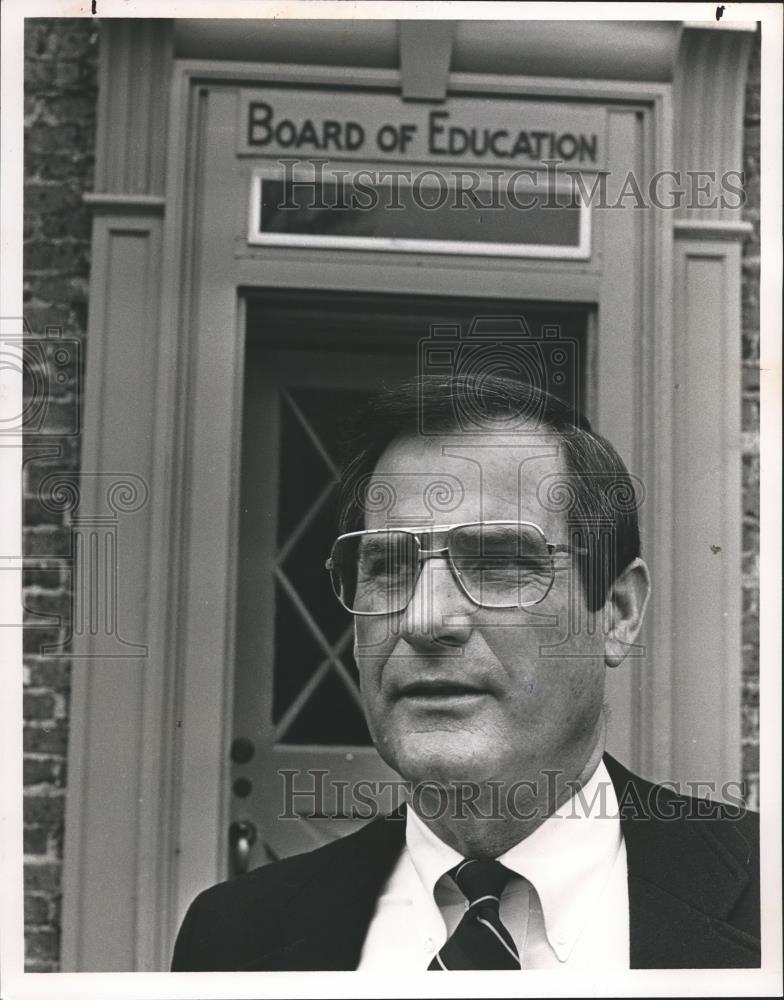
[173, 377, 759, 971]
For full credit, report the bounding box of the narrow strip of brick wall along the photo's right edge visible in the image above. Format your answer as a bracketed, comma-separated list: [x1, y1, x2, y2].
[741, 35, 760, 808]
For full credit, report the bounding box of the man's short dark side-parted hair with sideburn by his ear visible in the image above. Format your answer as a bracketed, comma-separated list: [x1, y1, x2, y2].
[339, 375, 640, 611]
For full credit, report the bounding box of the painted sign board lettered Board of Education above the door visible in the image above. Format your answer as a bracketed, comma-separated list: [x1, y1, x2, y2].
[238, 88, 606, 171]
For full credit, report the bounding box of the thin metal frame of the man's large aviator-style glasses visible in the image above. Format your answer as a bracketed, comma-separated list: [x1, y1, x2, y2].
[324, 521, 587, 618]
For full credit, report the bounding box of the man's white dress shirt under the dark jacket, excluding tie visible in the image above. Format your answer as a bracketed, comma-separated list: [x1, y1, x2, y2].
[358, 763, 629, 971]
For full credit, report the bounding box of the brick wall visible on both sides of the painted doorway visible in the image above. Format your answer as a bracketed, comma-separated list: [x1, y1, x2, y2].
[18, 20, 760, 971]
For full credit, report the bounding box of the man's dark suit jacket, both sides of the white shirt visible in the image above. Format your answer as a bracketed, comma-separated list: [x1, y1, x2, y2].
[172, 755, 760, 972]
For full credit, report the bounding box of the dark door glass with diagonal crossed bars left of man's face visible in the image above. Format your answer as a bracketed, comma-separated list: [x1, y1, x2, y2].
[272, 386, 370, 746]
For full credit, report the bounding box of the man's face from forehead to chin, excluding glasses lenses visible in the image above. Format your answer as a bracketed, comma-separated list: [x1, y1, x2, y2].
[355, 434, 605, 782]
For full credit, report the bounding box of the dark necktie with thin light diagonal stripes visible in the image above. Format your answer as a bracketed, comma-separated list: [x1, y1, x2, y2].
[428, 858, 520, 970]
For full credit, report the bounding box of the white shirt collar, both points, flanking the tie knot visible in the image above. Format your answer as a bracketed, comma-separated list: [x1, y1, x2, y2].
[406, 762, 622, 962]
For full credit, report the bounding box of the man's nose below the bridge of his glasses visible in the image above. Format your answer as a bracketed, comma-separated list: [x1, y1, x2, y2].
[401, 556, 476, 651]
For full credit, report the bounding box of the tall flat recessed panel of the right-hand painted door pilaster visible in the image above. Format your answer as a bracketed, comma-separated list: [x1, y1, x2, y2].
[672, 238, 742, 799]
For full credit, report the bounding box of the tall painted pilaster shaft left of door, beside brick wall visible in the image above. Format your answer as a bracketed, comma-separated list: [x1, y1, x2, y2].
[61, 213, 166, 971]
